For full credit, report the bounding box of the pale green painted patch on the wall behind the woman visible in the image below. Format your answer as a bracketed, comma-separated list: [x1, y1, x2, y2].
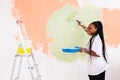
[47, 4, 102, 62]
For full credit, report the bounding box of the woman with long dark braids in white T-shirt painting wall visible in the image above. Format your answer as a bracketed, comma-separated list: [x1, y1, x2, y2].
[77, 21, 107, 80]
